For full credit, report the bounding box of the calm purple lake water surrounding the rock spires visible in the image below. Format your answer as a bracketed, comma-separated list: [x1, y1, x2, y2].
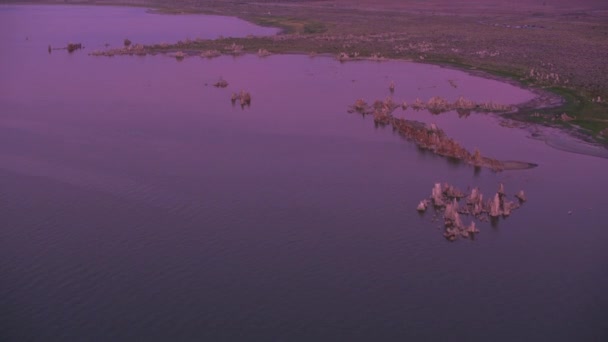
[0, 6, 608, 341]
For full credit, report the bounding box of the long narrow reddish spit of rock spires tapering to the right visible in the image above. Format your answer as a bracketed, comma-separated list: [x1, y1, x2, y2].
[349, 97, 516, 171]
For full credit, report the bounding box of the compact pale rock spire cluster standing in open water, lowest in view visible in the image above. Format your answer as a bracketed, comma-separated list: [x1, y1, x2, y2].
[416, 183, 526, 241]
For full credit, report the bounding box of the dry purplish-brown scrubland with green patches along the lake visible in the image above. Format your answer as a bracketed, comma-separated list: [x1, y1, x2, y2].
[8, 0, 608, 141]
